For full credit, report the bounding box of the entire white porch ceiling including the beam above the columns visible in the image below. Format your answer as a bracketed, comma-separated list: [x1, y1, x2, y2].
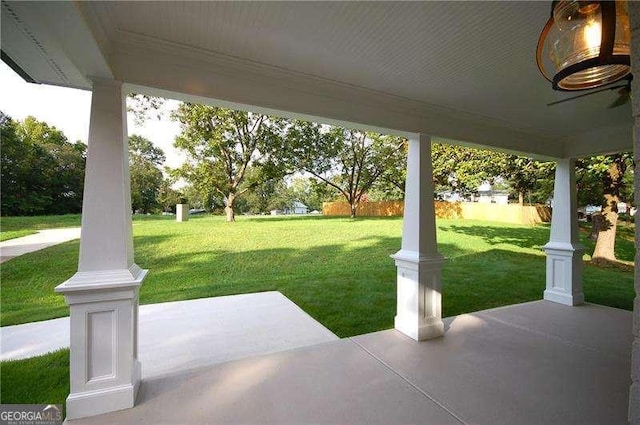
[2, 2, 632, 157]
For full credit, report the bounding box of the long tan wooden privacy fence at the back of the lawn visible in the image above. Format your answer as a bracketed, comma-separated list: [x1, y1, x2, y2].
[322, 201, 551, 224]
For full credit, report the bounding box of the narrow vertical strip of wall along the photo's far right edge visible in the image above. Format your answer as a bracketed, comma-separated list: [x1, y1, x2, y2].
[627, 1, 640, 424]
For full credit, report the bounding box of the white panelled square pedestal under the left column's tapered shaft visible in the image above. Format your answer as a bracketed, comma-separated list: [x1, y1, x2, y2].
[56, 264, 147, 419]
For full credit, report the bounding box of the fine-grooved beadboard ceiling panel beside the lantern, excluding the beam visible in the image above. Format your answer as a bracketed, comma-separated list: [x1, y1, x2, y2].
[99, 2, 630, 142]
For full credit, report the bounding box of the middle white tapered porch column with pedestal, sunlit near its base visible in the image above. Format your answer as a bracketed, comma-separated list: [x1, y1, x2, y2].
[393, 134, 444, 341]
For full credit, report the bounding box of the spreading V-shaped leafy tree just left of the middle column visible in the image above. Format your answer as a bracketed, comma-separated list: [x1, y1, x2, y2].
[286, 121, 406, 217]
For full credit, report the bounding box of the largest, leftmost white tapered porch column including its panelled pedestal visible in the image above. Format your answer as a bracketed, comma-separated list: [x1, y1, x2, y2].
[56, 79, 147, 419]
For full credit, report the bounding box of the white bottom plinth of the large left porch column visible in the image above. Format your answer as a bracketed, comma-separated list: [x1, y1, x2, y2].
[66, 361, 142, 420]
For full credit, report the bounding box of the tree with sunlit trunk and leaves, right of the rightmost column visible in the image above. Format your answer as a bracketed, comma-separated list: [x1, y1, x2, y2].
[577, 153, 633, 263]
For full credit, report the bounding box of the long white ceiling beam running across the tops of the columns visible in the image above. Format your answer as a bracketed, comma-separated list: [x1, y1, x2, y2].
[110, 33, 564, 158]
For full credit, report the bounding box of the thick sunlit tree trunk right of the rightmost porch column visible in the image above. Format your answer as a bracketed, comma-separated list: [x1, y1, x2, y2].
[591, 155, 626, 264]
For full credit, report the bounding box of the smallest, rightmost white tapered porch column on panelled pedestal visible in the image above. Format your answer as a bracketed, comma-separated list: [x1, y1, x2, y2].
[543, 159, 584, 305]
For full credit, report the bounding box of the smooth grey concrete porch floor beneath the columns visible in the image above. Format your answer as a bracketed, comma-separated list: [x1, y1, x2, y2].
[69, 301, 631, 425]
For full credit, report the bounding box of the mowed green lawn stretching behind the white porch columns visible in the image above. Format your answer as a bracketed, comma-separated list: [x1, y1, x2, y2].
[0, 216, 634, 410]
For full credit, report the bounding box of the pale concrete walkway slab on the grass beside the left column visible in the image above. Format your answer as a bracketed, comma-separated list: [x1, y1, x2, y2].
[0, 292, 338, 378]
